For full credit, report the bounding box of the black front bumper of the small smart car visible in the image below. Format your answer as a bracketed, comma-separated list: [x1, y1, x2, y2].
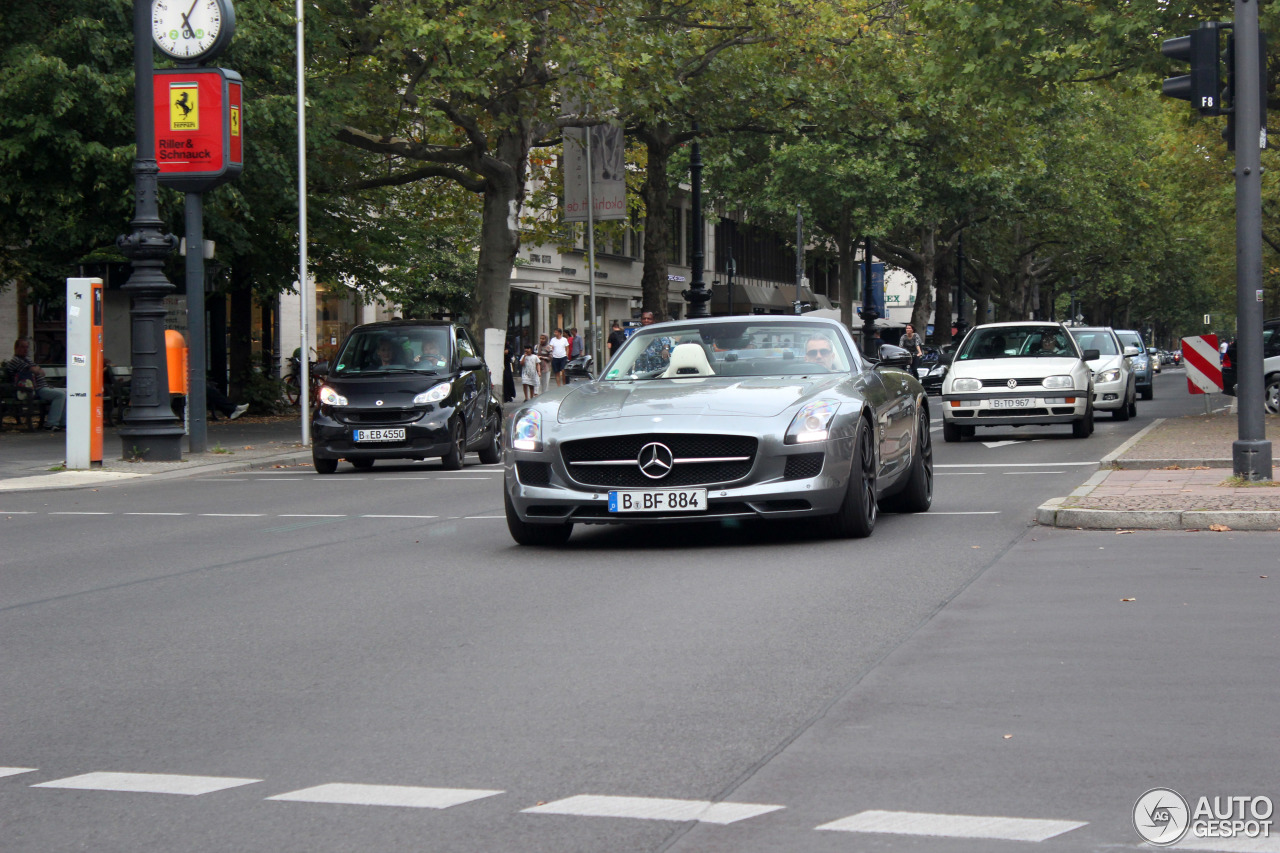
[311, 406, 454, 460]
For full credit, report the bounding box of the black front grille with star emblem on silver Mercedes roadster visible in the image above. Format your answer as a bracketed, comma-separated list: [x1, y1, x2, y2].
[561, 433, 759, 488]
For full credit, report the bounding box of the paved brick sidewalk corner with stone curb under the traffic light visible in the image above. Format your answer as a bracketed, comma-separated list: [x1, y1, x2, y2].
[1036, 406, 1280, 530]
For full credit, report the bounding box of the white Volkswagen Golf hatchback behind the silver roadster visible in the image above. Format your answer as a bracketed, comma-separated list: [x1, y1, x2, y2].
[942, 321, 1098, 442]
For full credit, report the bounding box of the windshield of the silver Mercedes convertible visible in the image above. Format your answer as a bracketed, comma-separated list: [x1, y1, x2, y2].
[604, 321, 854, 382]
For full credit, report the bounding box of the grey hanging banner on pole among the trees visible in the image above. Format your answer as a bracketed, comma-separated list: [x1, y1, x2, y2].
[561, 99, 627, 222]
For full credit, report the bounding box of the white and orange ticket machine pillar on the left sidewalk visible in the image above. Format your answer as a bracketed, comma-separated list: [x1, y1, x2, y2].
[67, 278, 102, 469]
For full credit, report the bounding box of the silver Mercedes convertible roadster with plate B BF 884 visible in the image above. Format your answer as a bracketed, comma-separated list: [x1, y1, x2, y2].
[503, 315, 933, 546]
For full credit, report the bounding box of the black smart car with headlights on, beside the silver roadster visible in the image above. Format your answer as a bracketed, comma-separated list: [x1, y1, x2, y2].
[311, 320, 502, 474]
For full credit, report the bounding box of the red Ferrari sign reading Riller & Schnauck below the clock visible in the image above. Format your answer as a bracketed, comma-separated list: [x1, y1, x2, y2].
[154, 68, 244, 192]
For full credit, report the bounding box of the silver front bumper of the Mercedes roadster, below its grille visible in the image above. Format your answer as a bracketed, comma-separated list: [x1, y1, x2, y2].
[503, 427, 852, 524]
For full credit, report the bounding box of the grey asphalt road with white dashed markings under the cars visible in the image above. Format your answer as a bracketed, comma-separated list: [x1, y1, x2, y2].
[0, 371, 1280, 853]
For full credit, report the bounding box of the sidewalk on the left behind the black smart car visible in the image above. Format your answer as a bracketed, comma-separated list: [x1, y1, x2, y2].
[0, 412, 311, 492]
